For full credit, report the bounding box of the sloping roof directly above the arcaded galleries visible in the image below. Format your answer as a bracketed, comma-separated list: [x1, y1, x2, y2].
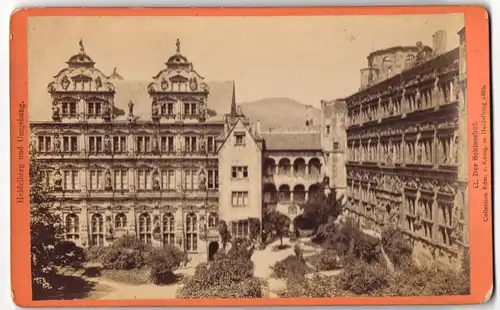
[260, 132, 321, 151]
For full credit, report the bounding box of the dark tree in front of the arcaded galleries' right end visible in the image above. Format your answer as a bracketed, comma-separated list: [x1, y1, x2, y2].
[301, 183, 344, 231]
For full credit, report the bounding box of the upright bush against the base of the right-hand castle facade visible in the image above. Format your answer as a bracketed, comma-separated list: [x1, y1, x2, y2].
[382, 227, 413, 268]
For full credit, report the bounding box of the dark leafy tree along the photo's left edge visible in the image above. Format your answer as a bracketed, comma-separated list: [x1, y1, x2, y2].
[29, 146, 63, 297]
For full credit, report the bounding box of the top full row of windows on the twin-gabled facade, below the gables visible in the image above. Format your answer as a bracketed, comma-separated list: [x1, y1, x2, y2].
[38, 135, 217, 153]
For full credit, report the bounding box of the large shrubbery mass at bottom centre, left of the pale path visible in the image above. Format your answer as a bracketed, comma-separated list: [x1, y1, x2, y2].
[177, 239, 262, 299]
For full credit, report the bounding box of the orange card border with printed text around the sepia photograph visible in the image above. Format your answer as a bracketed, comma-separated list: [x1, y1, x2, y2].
[10, 6, 493, 307]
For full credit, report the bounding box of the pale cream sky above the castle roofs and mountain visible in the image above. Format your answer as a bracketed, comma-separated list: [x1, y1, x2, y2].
[28, 14, 464, 107]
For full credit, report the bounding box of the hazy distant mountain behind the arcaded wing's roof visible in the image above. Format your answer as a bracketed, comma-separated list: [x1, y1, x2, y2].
[238, 97, 321, 130]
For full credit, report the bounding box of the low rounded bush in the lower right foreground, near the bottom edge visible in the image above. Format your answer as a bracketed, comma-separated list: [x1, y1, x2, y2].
[339, 261, 389, 295]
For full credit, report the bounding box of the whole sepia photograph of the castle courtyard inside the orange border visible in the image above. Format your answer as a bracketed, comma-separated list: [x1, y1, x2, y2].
[27, 13, 470, 300]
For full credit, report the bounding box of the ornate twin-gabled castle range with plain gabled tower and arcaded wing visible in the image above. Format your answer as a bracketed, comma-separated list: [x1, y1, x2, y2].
[30, 41, 332, 258]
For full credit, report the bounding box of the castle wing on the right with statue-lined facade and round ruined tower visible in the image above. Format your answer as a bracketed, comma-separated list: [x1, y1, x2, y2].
[345, 29, 469, 265]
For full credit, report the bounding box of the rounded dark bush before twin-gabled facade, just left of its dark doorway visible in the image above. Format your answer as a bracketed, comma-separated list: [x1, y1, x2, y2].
[146, 245, 185, 284]
